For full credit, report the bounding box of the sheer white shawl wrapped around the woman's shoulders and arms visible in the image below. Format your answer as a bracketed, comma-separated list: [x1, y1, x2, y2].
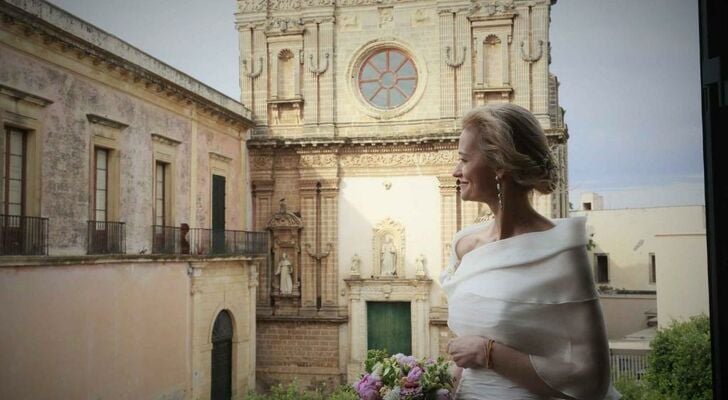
[441, 217, 620, 400]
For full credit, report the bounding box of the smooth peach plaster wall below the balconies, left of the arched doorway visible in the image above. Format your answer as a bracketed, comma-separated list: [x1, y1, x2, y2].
[0, 263, 191, 399]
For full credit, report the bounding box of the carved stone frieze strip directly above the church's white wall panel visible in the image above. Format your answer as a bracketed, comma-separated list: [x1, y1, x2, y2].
[340, 151, 457, 167]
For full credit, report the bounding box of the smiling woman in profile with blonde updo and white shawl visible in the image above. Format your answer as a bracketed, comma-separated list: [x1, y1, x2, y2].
[441, 104, 620, 400]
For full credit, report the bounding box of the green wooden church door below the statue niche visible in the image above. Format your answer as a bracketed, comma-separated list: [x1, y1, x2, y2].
[367, 301, 412, 355]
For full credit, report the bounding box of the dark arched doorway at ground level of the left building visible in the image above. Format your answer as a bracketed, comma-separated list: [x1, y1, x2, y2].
[210, 310, 233, 400]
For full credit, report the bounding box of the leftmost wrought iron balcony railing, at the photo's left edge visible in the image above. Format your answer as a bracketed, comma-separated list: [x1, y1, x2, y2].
[0, 214, 48, 256]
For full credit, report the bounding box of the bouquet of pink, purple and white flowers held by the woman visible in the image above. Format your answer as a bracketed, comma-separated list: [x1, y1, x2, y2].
[354, 350, 454, 400]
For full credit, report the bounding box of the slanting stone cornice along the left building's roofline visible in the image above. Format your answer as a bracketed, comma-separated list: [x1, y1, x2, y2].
[0, 0, 254, 127]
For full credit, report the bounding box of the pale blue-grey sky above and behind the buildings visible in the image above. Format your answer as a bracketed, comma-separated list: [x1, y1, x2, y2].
[45, 0, 704, 208]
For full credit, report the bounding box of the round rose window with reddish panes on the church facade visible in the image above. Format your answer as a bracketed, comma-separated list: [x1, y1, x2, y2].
[359, 49, 417, 110]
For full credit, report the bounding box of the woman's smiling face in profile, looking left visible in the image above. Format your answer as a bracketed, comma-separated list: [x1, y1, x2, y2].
[452, 129, 498, 203]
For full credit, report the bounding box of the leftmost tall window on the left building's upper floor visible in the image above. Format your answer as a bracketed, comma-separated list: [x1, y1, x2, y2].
[0, 128, 26, 216]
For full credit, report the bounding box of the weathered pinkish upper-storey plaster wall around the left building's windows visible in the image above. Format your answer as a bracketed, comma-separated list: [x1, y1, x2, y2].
[0, 37, 246, 255]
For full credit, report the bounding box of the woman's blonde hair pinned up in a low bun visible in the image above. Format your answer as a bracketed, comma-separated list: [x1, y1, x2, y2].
[463, 103, 558, 194]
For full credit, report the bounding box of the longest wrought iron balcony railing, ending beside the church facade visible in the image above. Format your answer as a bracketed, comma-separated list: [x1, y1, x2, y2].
[152, 224, 268, 256]
